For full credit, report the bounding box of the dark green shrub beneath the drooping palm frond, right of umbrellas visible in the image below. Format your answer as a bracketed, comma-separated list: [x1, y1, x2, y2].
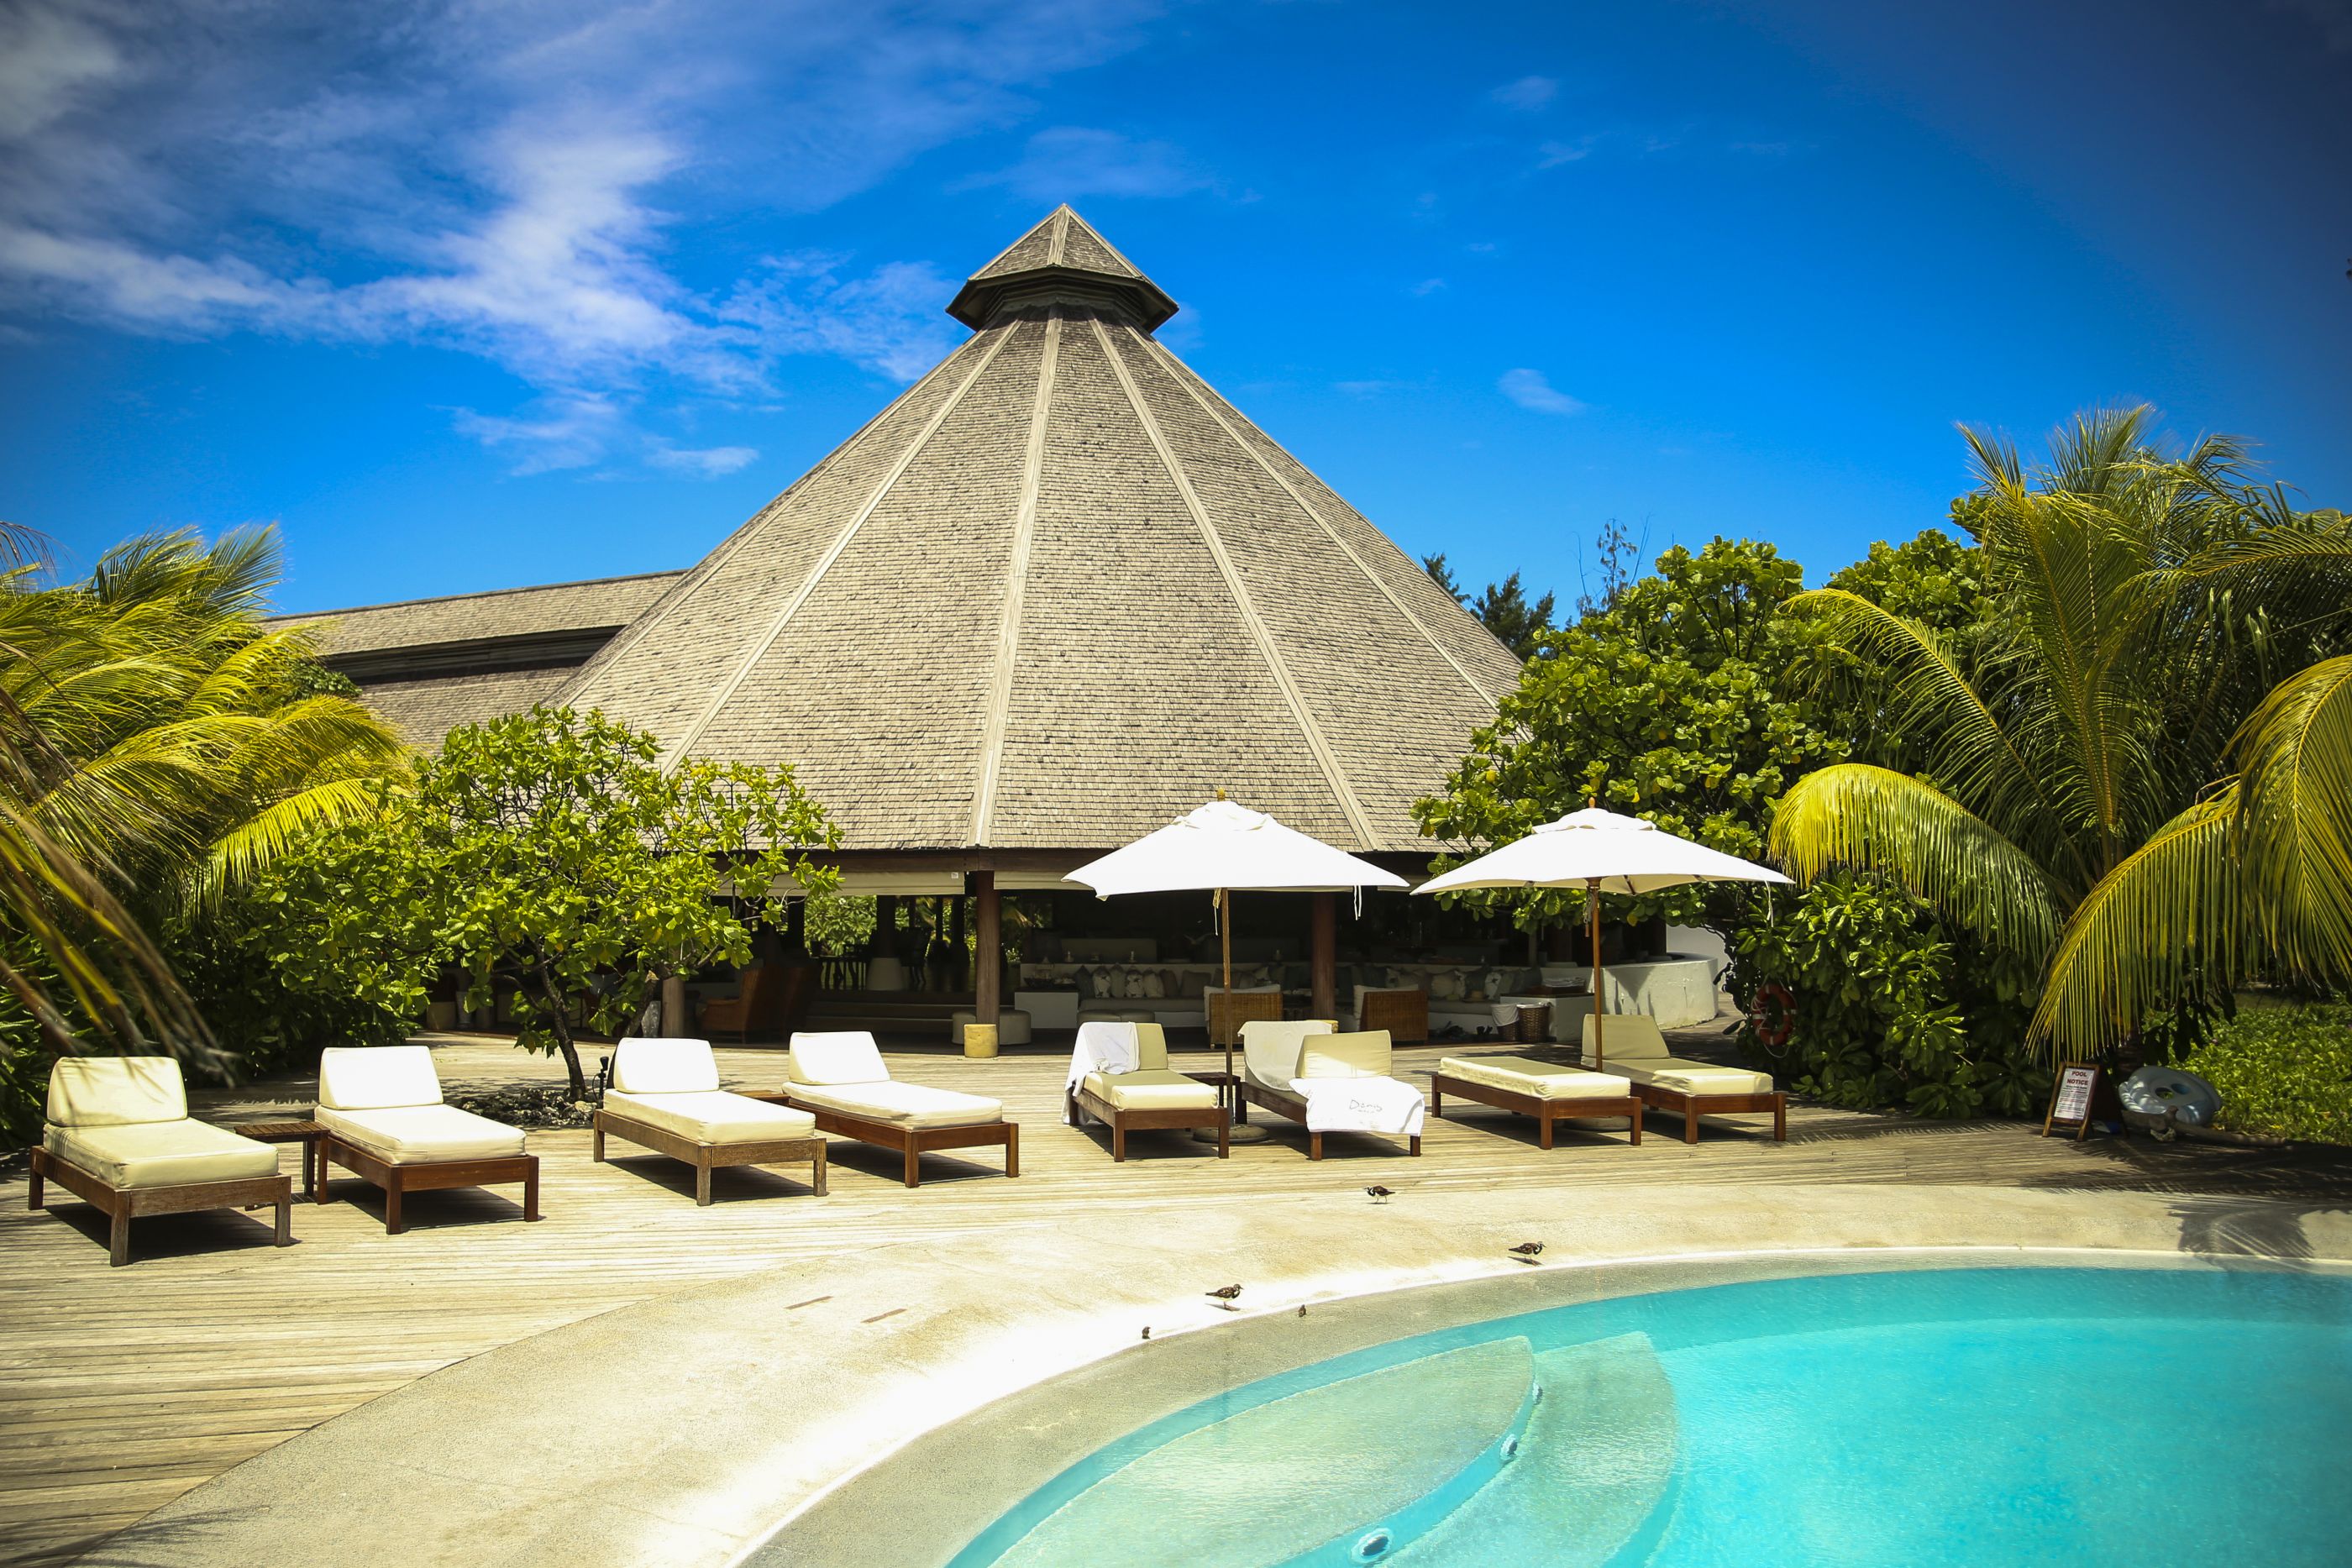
[1734, 877, 2049, 1117]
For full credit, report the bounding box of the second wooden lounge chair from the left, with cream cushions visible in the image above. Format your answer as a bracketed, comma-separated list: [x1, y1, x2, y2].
[318, 1046, 538, 1236]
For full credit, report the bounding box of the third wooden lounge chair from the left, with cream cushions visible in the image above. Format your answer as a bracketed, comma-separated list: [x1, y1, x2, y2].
[588, 1039, 826, 1209]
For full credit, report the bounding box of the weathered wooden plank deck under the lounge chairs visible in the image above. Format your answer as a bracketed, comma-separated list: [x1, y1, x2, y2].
[0, 1041, 2352, 1563]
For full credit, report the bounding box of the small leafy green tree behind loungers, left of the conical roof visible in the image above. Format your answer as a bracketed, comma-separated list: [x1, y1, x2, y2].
[402, 705, 840, 1093]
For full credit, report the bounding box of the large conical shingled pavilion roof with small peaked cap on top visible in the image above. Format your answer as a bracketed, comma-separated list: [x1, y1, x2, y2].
[562, 207, 1517, 851]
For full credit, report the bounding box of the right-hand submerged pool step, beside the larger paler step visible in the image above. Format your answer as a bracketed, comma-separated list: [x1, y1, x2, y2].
[1383, 1333, 1682, 1568]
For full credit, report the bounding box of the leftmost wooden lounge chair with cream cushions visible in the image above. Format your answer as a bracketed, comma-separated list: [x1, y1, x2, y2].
[29, 1056, 294, 1270]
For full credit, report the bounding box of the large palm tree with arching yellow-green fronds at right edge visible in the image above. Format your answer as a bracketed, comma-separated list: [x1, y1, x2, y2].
[1771, 409, 2352, 1053]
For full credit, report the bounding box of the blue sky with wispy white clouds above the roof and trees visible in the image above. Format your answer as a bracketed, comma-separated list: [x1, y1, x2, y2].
[0, 0, 2352, 609]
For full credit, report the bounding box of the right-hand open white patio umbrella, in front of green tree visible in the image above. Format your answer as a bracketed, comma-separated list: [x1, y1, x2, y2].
[1414, 806, 1788, 1067]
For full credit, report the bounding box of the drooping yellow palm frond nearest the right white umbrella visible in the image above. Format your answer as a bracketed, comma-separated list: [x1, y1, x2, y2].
[1771, 762, 2063, 957]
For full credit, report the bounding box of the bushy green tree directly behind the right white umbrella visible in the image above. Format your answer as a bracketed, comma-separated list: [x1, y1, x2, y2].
[1414, 538, 1844, 926]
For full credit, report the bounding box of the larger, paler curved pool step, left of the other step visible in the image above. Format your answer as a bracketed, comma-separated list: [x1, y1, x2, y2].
[997, 1338, 1541, 1568]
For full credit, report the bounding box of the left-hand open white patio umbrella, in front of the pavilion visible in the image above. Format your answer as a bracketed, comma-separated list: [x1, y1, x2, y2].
[1068, 789, 1404, 1072]
